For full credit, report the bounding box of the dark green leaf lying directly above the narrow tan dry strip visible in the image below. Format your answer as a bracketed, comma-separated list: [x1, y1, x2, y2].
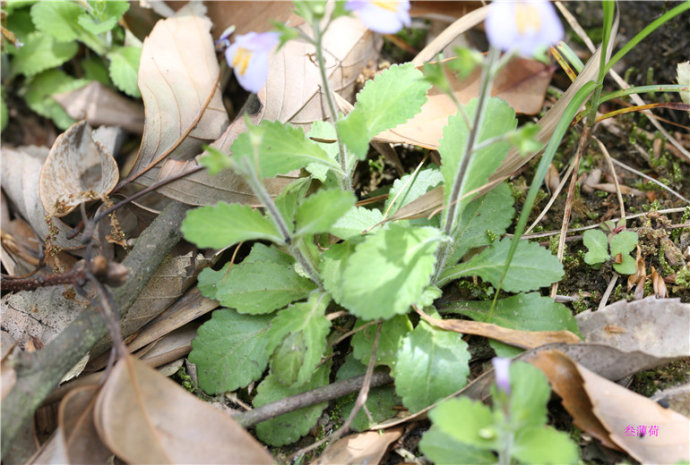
[446, 292, 579, 357]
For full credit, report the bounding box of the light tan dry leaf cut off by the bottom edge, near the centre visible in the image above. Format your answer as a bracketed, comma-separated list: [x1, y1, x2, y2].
[313, 429, 402, 465]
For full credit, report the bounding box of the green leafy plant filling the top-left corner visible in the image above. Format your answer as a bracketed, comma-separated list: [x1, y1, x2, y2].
[2, 0, 141, 129]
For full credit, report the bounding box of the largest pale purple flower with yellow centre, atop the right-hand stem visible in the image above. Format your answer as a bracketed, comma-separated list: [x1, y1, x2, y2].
[485, 0, 563, 56]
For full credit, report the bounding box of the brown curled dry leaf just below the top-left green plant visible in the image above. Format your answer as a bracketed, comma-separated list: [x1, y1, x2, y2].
[53, 81, 144, 134]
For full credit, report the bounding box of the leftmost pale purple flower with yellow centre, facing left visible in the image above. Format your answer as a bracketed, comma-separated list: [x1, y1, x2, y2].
[226, 32, 280, 93]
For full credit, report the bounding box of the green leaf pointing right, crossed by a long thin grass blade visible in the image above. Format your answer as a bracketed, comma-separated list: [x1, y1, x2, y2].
[439, 238, 563, 292]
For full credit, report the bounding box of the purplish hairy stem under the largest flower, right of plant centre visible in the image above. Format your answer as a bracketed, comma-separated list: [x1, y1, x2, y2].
[434, 47, 500, 281]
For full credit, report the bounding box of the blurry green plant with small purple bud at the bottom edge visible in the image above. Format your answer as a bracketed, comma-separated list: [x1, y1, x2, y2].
[419, 359, 578, 464]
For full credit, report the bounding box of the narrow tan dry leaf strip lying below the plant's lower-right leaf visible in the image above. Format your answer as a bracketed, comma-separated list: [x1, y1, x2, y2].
[420, 312, 580, 349]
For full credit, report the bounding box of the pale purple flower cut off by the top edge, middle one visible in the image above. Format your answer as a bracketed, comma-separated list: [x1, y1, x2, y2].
[345, 0, 410, 34]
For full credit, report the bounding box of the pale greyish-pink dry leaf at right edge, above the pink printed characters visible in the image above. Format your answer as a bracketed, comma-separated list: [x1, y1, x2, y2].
[575, 297, 690, 358]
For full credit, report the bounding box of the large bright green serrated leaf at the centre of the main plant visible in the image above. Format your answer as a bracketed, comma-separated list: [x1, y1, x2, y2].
[334, 224, 441, 320]
